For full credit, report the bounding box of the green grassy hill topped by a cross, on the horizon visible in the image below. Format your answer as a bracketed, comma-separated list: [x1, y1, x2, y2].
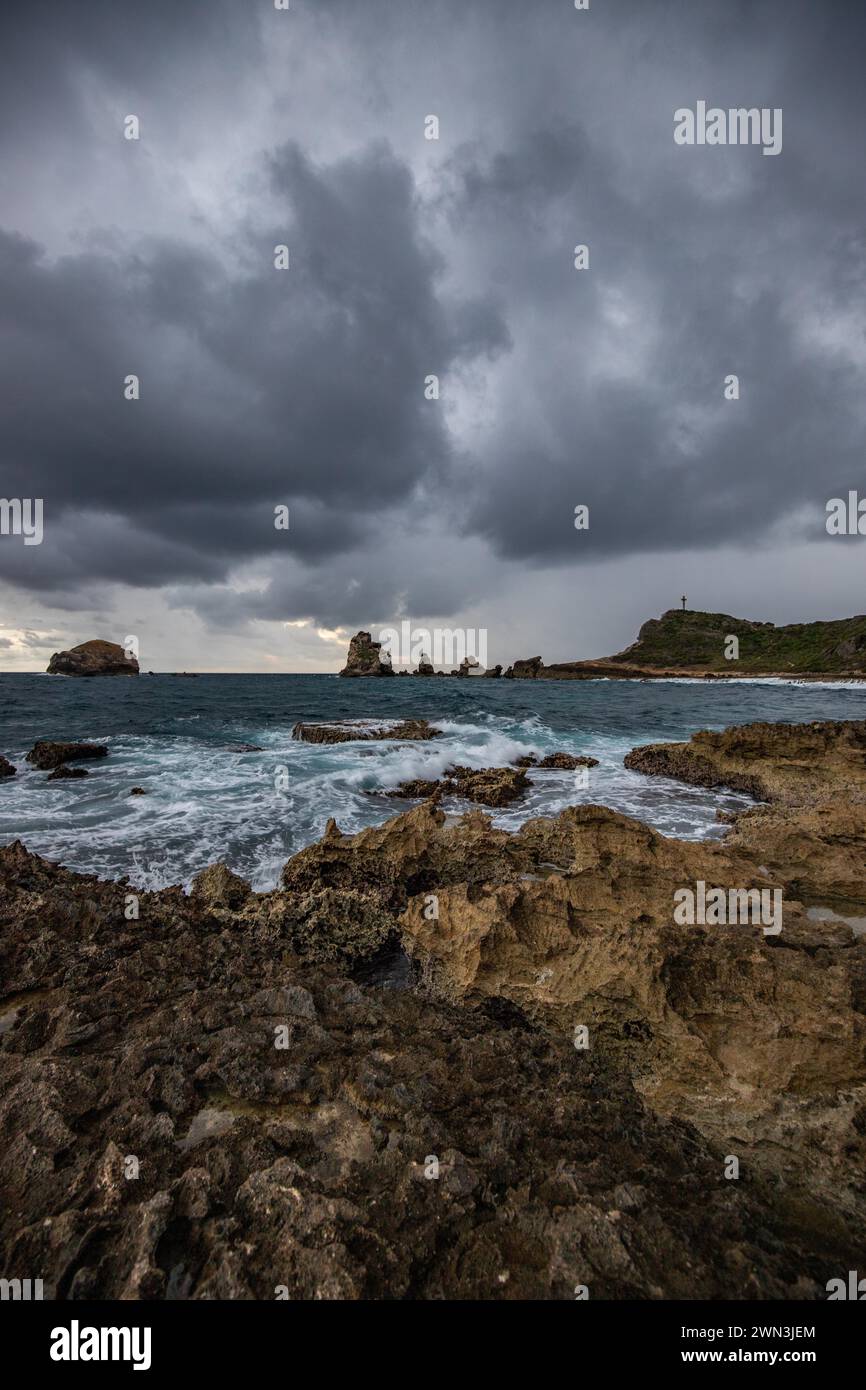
[609, 609, 866, 676]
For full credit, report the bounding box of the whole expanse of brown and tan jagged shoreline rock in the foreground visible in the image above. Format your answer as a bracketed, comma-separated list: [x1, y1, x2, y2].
[0, 723, 866, 1300]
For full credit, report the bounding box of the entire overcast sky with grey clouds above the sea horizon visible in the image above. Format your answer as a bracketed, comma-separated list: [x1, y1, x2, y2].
[0, 0, 866, 671]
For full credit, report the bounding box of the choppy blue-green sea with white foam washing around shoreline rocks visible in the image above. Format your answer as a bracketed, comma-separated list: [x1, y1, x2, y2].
[0, 674, 866, 890]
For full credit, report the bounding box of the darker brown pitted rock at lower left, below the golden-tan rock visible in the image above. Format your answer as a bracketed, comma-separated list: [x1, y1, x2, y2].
[0, 828, 858, 1300]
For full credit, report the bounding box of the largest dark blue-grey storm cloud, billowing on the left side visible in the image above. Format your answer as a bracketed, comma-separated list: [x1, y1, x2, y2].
[0, 146, 505, 587]
